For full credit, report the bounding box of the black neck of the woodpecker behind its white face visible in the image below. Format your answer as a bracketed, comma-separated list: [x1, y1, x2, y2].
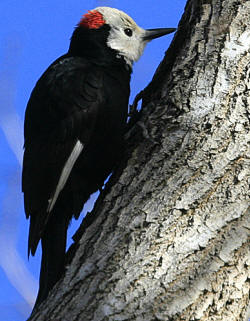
[68, 25, 132, 72]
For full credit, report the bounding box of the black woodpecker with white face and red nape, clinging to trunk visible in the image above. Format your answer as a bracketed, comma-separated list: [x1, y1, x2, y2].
[22, 7, 175, 309]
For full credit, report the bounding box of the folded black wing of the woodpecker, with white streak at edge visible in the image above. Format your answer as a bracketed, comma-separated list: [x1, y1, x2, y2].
[22, 56, 104, 255]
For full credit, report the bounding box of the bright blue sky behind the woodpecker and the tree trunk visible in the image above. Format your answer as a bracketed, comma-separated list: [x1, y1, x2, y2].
[0, 0, 186, 321]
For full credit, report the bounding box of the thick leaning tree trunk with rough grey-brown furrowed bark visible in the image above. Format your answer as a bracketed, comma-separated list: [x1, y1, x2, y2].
[31, 0, 250, 321]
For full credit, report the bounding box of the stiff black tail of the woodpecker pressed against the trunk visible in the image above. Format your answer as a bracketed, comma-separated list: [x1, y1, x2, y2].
[32, 212, 68, 313]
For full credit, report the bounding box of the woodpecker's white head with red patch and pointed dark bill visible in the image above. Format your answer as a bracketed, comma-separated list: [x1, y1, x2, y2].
[73, 7, 176, 66]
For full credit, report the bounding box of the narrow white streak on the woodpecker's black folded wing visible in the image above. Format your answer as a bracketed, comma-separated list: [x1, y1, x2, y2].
[47, 140, 83, 212]
